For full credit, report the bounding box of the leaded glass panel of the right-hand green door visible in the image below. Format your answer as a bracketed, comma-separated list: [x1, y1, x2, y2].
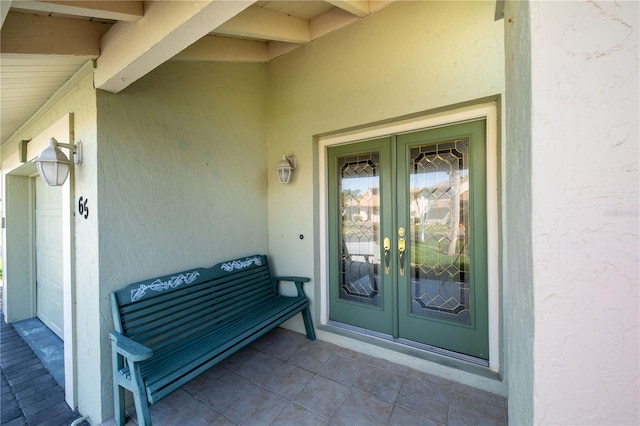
[408, 139, 472, 324]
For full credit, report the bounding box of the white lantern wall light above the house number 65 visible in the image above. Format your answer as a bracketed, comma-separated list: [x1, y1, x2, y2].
[36, 138, 82, 186]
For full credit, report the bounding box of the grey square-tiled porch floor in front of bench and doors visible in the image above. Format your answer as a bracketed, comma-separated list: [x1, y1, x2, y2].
[104, 328, 507, 426]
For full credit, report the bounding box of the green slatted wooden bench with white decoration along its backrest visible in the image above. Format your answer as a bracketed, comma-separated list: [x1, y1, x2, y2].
[111, 255, 315, 425]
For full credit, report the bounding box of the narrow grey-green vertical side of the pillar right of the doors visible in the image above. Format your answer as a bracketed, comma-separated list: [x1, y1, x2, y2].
[502, 2, 535, 425]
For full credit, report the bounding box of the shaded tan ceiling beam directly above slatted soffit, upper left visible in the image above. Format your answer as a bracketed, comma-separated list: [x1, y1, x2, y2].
[0, 12, 110, 59]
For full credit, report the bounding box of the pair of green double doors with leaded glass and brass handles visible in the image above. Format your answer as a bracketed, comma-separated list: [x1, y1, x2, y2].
[327, 120, 489, 359]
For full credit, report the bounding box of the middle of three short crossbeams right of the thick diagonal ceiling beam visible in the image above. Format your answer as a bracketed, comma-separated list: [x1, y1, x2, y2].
[215, 6, 311, 43]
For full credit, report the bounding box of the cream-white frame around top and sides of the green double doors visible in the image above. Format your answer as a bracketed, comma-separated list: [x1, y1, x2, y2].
[317, 102, 501, 372]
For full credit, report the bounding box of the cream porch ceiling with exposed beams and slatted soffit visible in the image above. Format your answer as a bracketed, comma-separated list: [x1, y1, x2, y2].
[0, 0, 392, 144]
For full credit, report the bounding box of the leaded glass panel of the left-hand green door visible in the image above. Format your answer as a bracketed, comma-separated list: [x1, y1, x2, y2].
[336, 152, 382, 306]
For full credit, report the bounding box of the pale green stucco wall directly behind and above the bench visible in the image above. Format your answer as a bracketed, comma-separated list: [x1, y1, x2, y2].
[95, 62, 267, 418]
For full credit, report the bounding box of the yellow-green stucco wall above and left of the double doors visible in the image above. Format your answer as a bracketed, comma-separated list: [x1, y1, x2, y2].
[268, 2, 504, 306]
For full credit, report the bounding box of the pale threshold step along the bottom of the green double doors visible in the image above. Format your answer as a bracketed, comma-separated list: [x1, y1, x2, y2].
[318, 320, 492, 374]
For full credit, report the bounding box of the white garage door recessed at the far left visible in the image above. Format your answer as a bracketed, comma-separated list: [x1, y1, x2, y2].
[36, 178, 63, 338]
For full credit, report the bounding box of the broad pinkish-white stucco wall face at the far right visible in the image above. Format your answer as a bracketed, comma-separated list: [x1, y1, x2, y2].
[528, 2, 640, 425]
